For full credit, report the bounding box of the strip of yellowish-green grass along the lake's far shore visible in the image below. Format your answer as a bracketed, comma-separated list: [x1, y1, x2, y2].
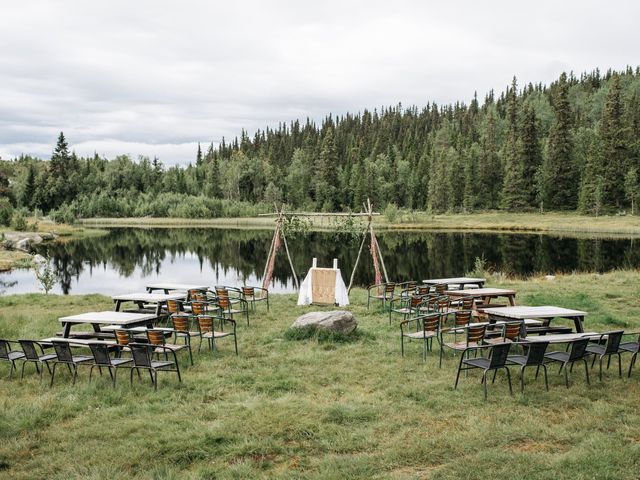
[81, 211, 640, 236]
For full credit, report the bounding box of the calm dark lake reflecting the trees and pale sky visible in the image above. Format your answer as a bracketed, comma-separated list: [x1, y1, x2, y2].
[0, 228, 640, 294]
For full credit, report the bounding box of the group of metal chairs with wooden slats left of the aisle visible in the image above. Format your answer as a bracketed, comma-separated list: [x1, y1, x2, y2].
[0, 287, 269, 389]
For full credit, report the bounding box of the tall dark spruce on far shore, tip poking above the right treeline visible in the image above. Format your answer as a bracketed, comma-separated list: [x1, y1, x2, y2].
[545, 72, 578, 210]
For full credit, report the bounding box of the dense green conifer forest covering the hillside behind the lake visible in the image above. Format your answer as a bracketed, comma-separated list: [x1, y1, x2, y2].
[0, 68, 640, 219]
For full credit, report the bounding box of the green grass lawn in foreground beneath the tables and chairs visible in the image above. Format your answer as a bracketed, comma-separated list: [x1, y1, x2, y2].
[0, 272, 640, 479]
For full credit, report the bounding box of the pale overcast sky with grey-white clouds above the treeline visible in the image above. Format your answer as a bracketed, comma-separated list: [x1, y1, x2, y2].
[0, 0, 640, 164]
